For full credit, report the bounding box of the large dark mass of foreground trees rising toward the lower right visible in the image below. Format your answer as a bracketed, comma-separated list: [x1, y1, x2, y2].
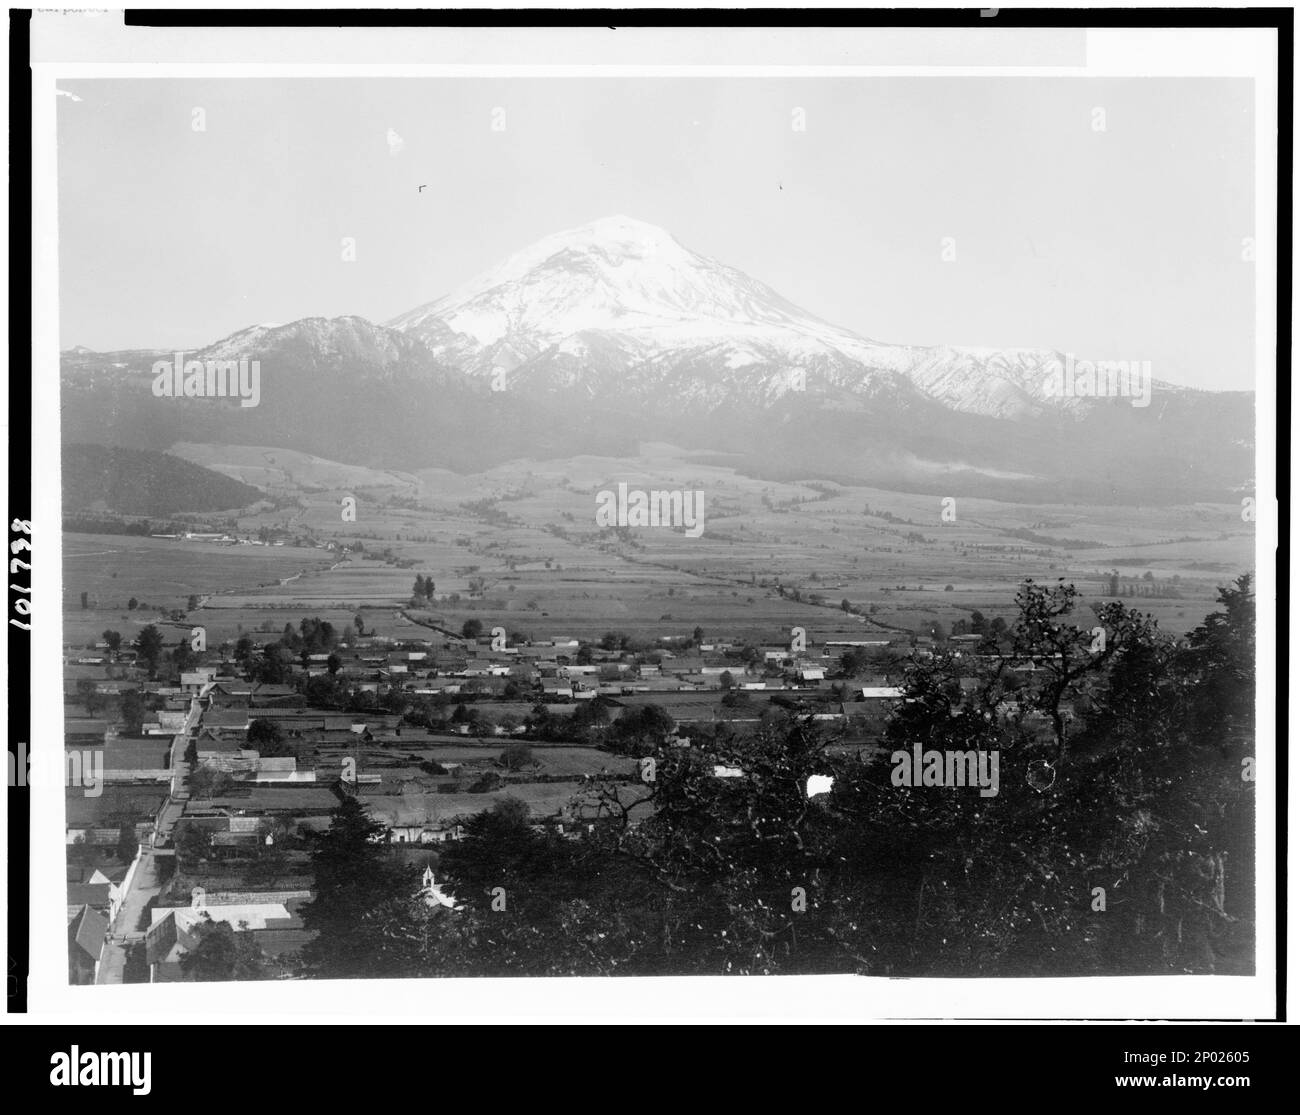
[297, 577, 1255, 976]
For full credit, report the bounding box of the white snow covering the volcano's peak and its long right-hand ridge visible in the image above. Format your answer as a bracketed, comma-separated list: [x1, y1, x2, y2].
[389, 217, 1123, 420]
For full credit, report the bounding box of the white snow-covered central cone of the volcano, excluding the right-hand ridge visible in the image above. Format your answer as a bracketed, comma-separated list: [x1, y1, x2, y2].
[389, 217, 925, 394]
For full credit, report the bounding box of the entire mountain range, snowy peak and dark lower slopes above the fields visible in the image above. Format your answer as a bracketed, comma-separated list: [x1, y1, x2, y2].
[62, 217, 1253, 502]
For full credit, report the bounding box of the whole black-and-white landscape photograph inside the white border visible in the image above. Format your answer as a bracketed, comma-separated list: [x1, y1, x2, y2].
[55, 63, 1256, 984]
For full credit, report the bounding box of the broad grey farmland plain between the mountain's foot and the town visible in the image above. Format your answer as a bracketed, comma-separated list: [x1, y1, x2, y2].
[64, 446, 1253, 652]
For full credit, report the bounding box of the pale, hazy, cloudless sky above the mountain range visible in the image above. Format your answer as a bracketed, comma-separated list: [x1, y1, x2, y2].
[59, 77, 1255, 387]
